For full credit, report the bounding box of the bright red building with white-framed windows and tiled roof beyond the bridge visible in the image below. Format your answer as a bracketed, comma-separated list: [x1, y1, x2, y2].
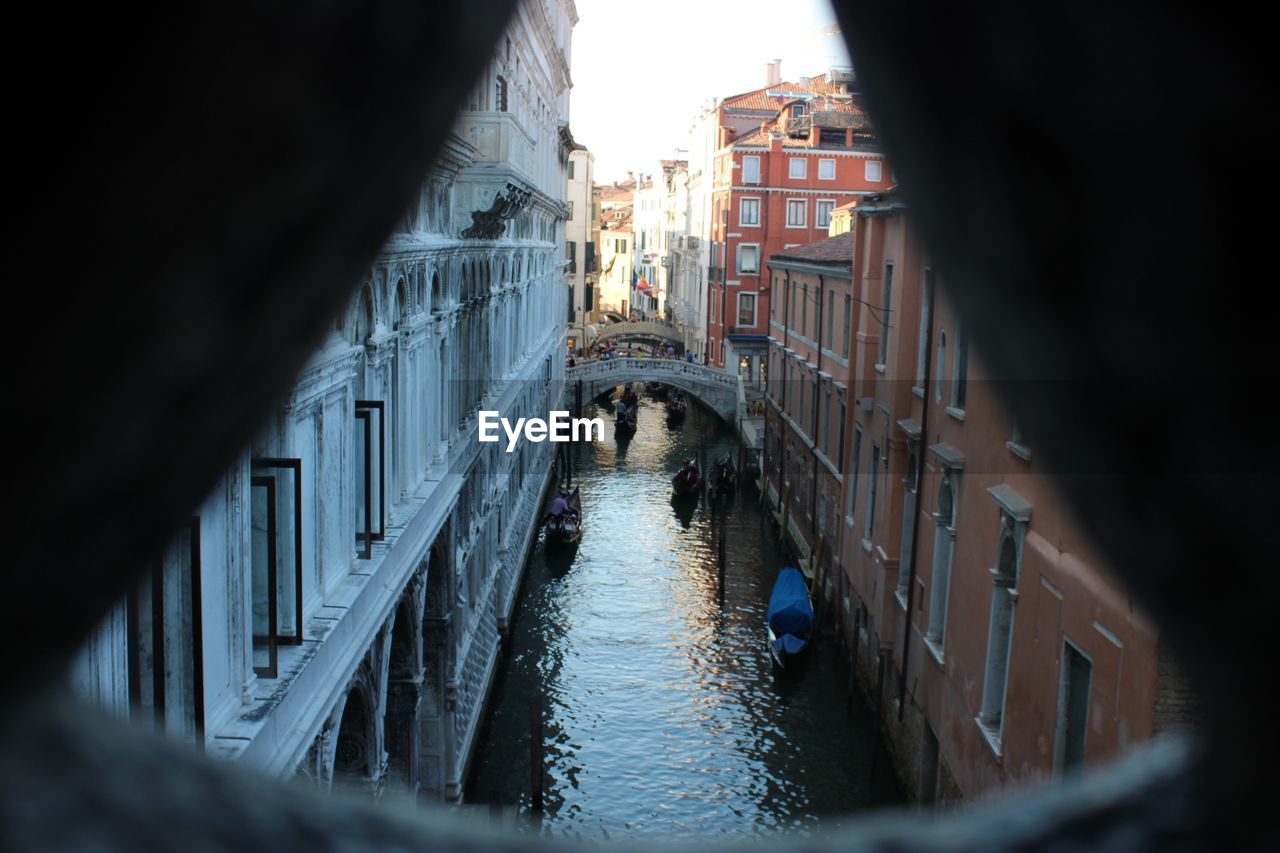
[707, 72, 893, 382]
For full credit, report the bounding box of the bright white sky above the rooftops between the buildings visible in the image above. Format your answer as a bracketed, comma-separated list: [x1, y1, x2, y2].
[570, 0, 849, 183]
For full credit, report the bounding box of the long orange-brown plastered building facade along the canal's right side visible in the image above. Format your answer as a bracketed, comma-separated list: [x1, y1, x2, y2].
[764, 193, 1194, 802]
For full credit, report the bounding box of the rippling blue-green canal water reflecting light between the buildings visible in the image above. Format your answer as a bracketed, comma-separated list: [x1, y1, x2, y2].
[466, 393, 901, 839]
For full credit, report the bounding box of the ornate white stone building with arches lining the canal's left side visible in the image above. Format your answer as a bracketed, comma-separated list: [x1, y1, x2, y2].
[72, 0, 577, 799]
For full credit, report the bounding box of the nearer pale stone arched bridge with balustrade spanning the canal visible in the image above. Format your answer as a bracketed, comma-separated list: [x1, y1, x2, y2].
[564, 353, 742, 423]
